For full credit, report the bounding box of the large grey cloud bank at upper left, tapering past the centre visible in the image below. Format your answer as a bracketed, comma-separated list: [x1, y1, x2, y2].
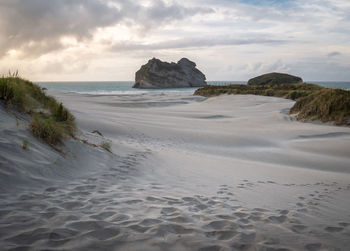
[0, 0, 212, 57]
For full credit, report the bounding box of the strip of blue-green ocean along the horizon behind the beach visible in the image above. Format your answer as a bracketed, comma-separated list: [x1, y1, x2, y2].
[37, 81, 350, 95]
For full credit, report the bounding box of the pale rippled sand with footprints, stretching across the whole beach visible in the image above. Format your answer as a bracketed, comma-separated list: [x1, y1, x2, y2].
[0, 93, 350, 250]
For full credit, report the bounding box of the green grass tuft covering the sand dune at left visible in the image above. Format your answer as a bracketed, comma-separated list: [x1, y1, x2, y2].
[0, 74, 76, 146]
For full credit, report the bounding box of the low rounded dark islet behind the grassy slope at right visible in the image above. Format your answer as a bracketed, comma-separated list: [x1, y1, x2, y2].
[248, 72, 303, 85]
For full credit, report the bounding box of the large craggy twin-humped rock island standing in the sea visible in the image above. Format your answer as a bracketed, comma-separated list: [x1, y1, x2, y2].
[133, 58, 207, 89]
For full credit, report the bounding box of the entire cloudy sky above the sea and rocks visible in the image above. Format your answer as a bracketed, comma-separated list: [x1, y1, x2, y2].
[0, 0, 350, 81]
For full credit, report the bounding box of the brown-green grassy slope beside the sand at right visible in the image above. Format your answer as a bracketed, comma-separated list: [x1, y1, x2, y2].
[194, 83, 350, 126]
